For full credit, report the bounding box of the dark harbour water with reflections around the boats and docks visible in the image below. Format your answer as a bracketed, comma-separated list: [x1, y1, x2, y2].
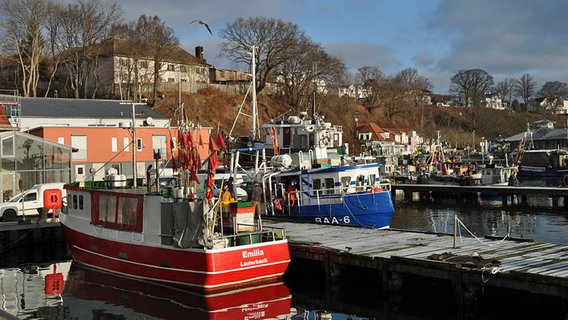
[0, 199, 568, 320]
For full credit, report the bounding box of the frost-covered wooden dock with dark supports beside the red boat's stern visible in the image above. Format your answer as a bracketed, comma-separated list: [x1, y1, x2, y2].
[264, 219, 568, 315]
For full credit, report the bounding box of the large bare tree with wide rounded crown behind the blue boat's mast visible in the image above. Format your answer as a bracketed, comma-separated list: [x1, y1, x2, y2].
[220, 17, 305, 92]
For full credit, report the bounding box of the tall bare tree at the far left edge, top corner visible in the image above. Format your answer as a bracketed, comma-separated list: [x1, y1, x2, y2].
[0, 0, 47, 97]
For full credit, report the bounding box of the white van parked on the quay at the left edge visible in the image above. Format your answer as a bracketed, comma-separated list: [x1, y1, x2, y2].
[0, 182, 66, 221]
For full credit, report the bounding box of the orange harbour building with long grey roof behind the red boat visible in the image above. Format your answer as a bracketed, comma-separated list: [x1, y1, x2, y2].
[2, 98, 211, 190]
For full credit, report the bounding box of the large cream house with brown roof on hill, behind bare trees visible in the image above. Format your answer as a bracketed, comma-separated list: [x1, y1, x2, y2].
[53, 39, 210, 100]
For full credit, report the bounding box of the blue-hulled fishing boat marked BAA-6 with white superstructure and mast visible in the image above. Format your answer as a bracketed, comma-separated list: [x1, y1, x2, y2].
[224, 48, 394, 228]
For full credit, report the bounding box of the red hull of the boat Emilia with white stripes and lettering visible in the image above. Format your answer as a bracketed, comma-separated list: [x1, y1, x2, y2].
[63, 225, 290, 292]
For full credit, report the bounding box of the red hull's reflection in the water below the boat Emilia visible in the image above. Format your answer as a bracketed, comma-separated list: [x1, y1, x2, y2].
[62, 264, 292, 319]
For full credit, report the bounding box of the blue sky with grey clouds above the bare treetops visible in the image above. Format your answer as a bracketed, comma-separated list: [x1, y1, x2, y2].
[111, 0, 568, 94]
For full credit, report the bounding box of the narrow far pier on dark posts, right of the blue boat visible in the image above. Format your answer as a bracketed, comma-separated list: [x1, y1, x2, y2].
[392, 183, 568, 209]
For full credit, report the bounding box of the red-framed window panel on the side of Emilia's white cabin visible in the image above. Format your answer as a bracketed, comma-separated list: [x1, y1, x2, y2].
[93, 193, 143, 231]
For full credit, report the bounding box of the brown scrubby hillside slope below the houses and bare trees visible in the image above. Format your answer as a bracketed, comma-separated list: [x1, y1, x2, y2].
[155, 88, 566, 150]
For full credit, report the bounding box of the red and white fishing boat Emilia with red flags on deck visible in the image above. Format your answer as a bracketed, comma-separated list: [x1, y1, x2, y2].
[58, 115, 290, 292]
